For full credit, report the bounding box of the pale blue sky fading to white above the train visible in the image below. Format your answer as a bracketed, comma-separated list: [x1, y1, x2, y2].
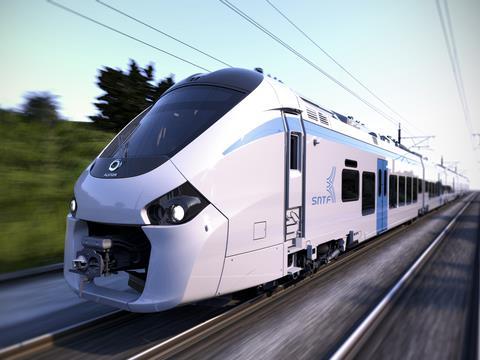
[0, 0, 480, 189]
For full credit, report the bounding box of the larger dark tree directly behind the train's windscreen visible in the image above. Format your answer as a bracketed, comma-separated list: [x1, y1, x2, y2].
[90, 60, 174, 131]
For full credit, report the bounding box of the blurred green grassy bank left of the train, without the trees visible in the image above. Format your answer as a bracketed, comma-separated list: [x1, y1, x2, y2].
[0, 111, 113, 273]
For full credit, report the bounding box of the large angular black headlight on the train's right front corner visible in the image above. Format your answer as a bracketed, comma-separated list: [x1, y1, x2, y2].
[146, 182, 209, 225]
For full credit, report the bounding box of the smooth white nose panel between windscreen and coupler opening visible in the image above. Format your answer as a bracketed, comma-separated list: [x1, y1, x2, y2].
[75, 161, 186, 225]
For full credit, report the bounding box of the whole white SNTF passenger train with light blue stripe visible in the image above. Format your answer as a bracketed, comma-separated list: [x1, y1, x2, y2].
[64, 69, 468, 312]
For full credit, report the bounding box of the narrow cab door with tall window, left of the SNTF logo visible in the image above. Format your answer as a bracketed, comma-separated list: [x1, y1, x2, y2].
[284, 112, 305, 245]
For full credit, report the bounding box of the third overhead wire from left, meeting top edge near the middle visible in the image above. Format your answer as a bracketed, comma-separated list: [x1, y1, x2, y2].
[219, 0, 414, 135]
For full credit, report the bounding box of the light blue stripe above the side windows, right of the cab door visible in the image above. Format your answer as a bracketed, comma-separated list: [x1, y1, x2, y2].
[304, 121, 420, 164]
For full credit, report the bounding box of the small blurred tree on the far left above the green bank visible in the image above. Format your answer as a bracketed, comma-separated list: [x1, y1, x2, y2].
[22, 91, 60, 124]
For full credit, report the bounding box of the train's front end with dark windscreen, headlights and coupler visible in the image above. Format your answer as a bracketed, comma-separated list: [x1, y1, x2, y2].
[64, 69, 263, 312]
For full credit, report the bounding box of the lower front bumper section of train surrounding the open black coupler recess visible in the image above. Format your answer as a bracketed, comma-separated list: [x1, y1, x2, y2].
[64, 204, 228, 312]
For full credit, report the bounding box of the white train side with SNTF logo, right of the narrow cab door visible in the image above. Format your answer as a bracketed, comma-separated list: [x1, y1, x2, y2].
[305, 117, 423, 250]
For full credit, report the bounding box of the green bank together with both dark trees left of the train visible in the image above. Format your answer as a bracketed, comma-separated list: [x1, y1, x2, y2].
[0, 60, 173, 272]
